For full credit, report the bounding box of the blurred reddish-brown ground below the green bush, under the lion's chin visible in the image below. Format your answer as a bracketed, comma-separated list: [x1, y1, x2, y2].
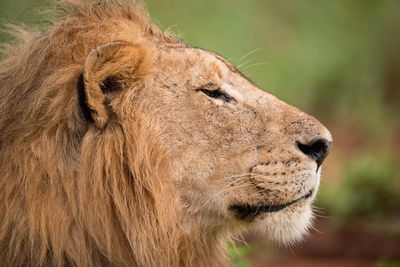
[251, 220, 400, 267]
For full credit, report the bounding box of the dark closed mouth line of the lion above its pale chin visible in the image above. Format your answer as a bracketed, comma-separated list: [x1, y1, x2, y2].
[229, 190, 313, 220]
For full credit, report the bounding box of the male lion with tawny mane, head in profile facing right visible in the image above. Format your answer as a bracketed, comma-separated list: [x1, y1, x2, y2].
[0, 0, 332, 266]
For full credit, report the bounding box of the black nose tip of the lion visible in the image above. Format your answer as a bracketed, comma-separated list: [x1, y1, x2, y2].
[297, 138, 332, 168]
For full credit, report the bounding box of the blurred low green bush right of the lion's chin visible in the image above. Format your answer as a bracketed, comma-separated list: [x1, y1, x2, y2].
[317, 155, 400, 221]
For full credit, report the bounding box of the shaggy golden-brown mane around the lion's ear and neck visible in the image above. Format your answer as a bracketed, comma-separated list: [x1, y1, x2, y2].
[0, 1, 226, 266]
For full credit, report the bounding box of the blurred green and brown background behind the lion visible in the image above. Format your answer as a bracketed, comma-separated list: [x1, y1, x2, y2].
[0, 0, 400, 266]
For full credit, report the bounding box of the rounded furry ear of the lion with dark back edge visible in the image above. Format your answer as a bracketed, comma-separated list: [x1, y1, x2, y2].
[78, 41, 146, 128]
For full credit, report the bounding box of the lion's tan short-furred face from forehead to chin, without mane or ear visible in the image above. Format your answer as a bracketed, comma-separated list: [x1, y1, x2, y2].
[104, 45, 332, 245]
